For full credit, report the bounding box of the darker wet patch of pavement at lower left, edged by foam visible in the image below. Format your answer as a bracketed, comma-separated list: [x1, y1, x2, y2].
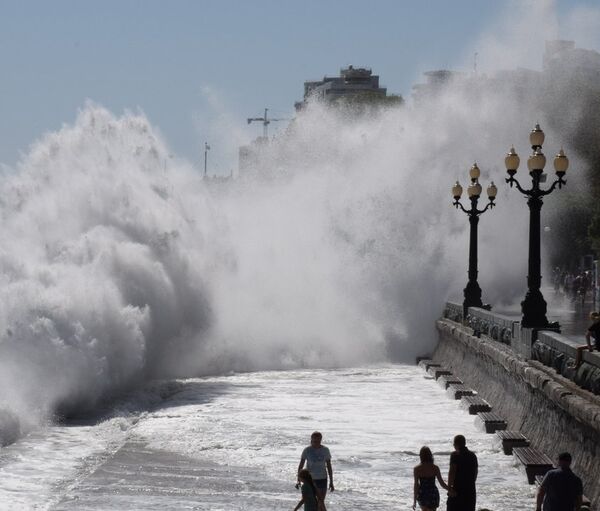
[51, 442, 286, 511]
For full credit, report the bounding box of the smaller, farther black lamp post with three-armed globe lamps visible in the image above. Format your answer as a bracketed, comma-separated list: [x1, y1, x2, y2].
[452, 163, 498, 318]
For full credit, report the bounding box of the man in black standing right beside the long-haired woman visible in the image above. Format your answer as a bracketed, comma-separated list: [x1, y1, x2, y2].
[446, 435, 478, 511]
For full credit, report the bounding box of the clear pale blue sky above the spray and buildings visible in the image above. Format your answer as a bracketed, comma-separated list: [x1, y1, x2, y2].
[0, 0, 600, 172]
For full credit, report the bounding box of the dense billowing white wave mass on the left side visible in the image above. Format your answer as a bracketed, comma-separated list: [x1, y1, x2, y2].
[0, 104, 218, 432]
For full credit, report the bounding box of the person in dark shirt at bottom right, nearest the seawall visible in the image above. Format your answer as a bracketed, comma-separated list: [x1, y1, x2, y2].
[536, 452, 583, 511]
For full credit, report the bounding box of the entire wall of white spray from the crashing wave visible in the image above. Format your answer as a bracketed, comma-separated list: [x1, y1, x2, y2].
[0, 1, 596, 440]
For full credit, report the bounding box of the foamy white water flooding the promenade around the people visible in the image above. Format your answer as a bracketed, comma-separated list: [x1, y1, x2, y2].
[0, 365, 535, 511]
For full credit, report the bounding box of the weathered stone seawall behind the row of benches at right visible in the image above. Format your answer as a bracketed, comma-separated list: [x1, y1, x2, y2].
[433, 319, 600, 509]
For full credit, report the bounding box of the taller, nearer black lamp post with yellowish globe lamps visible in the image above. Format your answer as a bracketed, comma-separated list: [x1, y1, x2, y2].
[504, 124, 569, 329]
